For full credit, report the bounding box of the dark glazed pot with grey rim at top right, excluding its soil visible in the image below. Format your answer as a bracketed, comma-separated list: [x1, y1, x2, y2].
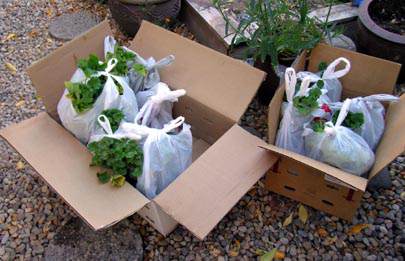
[357, 0, 405, 83]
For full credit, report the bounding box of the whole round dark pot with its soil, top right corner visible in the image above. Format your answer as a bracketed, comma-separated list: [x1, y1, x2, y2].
[357, 0, 405, 82]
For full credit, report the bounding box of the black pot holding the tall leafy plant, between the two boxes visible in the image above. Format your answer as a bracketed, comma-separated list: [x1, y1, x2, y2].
[254, 57, 295, 106]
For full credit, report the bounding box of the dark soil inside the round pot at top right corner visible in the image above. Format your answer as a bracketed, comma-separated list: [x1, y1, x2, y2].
[368, 0, 405, 35]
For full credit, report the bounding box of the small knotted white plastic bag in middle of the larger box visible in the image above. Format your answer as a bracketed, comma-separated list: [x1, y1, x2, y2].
[135, 82, 186, 129]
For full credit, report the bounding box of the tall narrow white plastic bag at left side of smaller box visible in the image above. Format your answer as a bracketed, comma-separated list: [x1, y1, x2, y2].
[276, 68, 312, 154]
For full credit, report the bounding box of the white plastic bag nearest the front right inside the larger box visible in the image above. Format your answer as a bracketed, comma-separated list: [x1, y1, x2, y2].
[117, 117, 193, 199]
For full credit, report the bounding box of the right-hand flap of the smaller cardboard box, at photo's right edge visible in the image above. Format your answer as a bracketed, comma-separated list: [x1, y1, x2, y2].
[369, 94, 405, 178]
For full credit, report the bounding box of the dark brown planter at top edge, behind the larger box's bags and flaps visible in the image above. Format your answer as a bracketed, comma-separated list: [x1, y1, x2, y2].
[108, 0, 181, 36]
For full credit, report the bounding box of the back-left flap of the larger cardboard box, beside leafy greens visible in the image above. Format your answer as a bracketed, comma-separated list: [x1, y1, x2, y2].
[27, 20, 112, 120]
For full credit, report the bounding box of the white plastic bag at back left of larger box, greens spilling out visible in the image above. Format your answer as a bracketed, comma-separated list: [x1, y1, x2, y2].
[57, 59, 138, 144]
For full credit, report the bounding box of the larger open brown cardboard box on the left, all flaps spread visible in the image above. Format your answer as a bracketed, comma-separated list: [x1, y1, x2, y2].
[0, 22, 276, 239]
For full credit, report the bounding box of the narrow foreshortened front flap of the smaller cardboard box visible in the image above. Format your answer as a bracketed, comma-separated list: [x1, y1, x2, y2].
[262, 144, 367, 191]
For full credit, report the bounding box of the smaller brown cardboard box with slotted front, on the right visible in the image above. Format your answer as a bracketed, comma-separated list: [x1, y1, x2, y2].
[266, 44, 405, 220]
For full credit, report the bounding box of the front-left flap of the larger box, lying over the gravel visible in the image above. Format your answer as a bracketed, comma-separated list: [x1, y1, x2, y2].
[0, 112, 148, 230]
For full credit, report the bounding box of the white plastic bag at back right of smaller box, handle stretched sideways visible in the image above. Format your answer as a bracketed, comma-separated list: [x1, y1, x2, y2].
[331, 94, 399, 150]
